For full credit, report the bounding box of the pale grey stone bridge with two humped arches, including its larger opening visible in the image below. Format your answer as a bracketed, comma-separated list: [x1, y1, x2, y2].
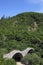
[3, 48, 34, 61]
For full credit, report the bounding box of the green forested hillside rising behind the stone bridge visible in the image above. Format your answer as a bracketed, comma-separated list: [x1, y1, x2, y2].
[0, 12, 43, 62]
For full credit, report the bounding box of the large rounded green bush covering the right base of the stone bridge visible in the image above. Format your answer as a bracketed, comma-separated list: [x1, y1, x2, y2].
[22, 53, 40, 65]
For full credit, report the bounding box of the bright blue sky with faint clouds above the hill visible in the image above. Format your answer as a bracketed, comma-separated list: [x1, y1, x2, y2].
[0, 0, 43, 18]
